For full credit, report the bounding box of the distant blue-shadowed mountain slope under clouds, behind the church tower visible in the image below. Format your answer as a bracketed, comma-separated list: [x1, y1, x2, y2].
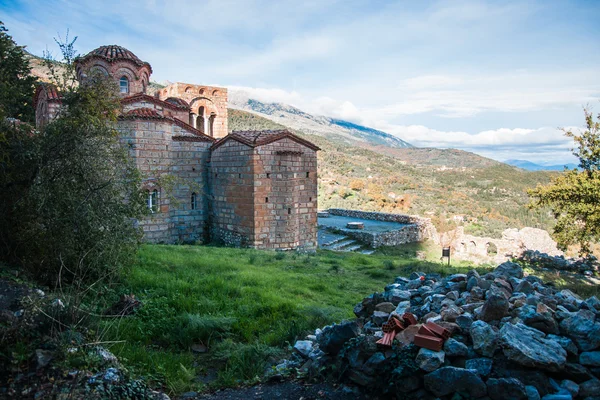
[228, 89, 413, 148]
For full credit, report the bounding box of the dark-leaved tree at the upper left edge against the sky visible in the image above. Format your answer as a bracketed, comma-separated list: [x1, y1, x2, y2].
[0, 21, 36, 121]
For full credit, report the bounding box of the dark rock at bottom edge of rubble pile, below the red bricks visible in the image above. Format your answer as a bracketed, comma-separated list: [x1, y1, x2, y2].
[423, 367, 487, 398]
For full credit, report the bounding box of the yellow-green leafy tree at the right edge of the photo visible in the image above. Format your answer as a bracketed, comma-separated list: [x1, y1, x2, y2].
[528, 109, 600, 255]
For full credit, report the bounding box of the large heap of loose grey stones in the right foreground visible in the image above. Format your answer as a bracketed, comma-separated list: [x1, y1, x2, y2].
[286, 262, 600, 400]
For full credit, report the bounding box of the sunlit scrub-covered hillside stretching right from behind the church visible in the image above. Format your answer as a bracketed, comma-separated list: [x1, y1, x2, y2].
[229, 109, 553, 236]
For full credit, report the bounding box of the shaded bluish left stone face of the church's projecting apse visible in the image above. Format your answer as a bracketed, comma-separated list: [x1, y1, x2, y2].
[208, 140, 254, 247]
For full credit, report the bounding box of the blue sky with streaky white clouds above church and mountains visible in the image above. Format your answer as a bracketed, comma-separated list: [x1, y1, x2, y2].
[0, 0, 600, 164]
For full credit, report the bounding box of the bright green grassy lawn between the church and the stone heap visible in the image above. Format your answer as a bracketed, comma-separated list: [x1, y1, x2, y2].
[101, 245, 482, 393]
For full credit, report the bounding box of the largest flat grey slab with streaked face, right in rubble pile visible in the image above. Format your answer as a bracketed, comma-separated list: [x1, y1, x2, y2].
[500, 323, 567, 372]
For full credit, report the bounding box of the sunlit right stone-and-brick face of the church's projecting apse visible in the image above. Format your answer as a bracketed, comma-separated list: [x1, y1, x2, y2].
[253, 138, 317, 249]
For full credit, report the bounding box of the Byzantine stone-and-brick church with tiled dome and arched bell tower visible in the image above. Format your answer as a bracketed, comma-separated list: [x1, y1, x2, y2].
[34, 45, 319, 249]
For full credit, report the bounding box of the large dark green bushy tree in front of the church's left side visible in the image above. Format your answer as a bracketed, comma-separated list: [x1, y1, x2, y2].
[0, 30, 146, 284]
